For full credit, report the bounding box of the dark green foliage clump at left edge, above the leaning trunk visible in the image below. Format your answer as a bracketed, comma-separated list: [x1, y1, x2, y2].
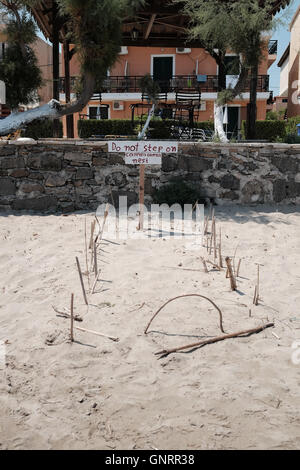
[0, 43, 43, 109]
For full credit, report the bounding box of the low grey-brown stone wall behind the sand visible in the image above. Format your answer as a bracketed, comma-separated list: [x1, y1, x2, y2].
[0, 140, 300, 212]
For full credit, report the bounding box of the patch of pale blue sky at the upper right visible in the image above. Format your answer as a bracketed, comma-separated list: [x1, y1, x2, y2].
[268, 0, 300, 96]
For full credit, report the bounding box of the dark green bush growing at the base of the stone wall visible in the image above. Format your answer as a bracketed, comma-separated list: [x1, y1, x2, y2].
[153, 181, 204, 207]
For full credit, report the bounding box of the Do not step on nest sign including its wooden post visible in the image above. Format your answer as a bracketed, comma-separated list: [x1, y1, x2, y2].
[108, 140, 178, 230]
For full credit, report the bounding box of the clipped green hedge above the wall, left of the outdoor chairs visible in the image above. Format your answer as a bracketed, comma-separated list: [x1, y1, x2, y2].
[78, 119, 134, 139]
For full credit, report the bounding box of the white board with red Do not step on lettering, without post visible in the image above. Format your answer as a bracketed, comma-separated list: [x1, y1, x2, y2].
[108, 140, 178, 165]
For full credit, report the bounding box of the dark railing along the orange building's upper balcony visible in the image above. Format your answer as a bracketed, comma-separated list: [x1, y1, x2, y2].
[60, 75, 269, 95]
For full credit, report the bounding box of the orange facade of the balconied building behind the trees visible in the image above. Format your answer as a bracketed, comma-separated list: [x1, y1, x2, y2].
[60, 41, 277, 137]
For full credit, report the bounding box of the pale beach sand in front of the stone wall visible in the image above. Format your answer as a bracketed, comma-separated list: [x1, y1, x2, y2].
[0, 207, 300, 449]
